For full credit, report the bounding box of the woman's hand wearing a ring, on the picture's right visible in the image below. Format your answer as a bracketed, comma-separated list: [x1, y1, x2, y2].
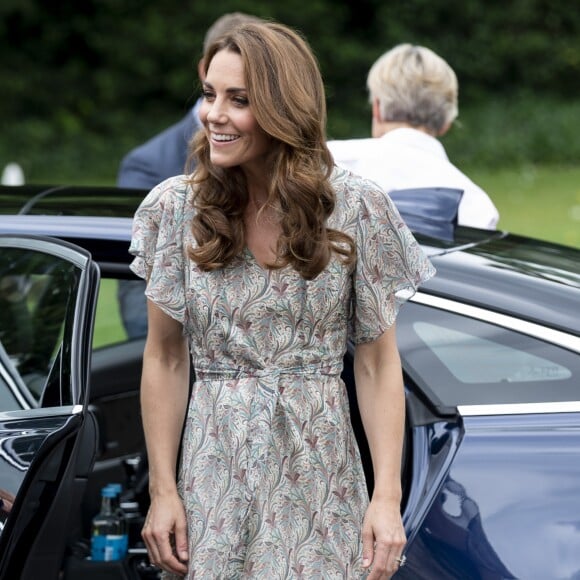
[362, 499, 407, 580]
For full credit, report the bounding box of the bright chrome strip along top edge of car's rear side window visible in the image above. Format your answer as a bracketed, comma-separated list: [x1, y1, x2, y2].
[410, 292, 580, 353]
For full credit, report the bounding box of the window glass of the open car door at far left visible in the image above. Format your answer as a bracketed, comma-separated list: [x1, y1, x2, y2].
[0, 248, 80, 410]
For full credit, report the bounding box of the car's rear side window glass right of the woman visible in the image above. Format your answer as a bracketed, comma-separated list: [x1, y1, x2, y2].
[397, 302, 580, 407]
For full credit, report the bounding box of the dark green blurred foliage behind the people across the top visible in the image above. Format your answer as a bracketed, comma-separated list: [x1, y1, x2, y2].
[0, 0, 580, 183]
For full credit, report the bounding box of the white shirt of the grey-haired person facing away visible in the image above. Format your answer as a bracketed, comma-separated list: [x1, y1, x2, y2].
[327, 127, 499, 229]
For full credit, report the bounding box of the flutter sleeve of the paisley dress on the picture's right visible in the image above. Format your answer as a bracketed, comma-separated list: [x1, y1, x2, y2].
[351, 180, 435, 343]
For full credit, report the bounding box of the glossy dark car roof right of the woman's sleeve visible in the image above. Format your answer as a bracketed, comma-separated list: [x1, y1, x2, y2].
[423, 235, 580, 336]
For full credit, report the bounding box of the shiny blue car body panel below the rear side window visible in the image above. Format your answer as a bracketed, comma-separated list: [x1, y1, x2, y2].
[397, 413, 580, 580]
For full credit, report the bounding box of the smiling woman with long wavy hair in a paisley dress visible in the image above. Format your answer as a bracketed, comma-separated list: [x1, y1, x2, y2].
[131, 23, 433, 579]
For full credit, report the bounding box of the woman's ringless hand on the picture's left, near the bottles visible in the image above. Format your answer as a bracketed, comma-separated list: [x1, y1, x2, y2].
[141, 493, 188, 576]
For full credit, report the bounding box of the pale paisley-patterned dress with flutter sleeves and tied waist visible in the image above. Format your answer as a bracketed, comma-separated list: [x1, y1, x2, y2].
[131, 169, 434, 580]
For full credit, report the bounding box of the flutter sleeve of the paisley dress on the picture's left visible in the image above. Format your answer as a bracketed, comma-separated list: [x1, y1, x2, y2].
[129, 176, 191, 328]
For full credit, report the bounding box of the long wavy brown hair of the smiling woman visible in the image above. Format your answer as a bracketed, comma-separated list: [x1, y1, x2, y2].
[189, 22, 356, 280]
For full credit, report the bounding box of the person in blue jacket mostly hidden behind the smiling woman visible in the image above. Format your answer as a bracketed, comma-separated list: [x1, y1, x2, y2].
[117, 12, 262, 338]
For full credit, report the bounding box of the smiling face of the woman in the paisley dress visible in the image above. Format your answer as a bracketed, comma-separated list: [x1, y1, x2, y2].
[199, 50, 271, 173]
